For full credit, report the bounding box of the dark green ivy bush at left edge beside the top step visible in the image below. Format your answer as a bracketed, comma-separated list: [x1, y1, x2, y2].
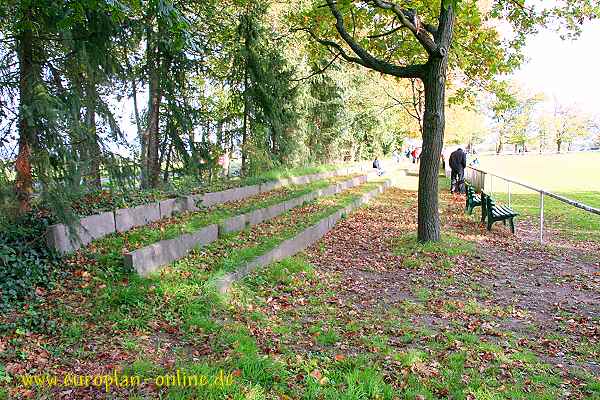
[0, 213, 60, 312]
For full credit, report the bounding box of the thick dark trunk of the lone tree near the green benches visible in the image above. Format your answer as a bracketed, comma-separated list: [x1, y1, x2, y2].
[417, 5, 455, 242]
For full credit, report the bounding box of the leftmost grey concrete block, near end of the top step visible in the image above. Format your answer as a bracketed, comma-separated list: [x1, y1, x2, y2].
[46, 211, 116, 254]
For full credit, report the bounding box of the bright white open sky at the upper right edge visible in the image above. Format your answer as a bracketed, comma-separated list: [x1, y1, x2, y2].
[514, 20, 600, 116]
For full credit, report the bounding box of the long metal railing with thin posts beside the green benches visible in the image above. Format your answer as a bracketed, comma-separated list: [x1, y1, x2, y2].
[465, 167, 600, 243]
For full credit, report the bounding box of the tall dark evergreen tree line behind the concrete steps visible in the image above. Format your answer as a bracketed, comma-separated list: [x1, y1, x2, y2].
[0, 0, 436, 219]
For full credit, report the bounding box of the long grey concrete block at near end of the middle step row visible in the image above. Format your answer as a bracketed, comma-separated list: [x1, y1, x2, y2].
[123, 225, 218, 276]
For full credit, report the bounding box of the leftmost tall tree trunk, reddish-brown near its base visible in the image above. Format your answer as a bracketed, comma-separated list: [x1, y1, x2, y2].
[15, 8, 37, 214]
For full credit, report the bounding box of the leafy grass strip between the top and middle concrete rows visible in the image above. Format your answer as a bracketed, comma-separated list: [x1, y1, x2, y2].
[83, 175, 358, 267]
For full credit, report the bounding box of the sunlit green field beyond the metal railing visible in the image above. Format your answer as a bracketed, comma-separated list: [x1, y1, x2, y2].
[472, 153, 600, 241]
